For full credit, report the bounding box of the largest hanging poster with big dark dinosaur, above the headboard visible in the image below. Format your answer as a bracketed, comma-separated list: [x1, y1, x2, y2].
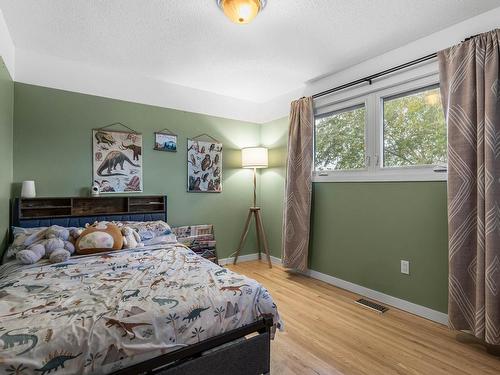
[92, 129, 143, 193]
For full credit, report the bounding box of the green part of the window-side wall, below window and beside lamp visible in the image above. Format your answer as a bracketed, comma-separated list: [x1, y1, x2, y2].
[261, 118, 448, 312]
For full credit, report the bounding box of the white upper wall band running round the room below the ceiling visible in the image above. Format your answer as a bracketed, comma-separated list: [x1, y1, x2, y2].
[0, 7, 500, 123]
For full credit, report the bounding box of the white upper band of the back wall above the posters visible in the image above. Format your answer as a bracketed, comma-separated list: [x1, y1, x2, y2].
[16, 48, 266, 122]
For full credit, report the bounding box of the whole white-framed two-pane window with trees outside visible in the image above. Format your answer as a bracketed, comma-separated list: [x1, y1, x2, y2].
[314, 74, 447, 182]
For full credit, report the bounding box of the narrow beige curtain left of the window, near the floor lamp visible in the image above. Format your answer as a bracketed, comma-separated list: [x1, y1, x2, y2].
[283, 98, 314, 271]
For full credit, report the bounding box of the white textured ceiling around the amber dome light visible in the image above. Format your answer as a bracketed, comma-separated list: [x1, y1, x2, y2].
[0, 0, 500, 103]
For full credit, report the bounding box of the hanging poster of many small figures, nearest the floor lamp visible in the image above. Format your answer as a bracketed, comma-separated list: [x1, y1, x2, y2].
[187, 139, 222, 193]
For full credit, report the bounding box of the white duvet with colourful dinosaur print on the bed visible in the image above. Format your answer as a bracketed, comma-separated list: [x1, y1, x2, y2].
[0, 244, 280, 375]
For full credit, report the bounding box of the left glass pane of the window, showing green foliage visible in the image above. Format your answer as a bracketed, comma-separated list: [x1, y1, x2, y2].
[315, 105, 366, 171]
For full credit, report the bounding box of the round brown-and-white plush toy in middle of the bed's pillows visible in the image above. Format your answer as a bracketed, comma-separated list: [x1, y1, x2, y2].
[75, 221, 123, 254]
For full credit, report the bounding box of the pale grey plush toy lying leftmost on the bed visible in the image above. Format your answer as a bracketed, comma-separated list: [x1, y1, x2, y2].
[16, 225, 75, 264]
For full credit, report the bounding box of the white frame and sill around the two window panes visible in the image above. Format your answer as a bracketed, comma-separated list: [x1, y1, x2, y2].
[313, 69, 448, 182]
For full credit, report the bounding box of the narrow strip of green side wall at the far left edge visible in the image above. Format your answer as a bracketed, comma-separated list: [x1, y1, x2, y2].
[0, 57, 14, 255]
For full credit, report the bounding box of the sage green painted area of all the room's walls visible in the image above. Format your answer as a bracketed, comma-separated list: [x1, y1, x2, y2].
[11, 84, 448, 312]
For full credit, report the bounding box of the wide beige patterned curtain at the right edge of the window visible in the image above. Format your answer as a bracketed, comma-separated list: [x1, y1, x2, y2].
[438, 30, 500, 345]
